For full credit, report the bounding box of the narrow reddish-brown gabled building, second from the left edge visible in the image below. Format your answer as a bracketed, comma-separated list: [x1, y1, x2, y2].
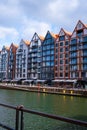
[8, 43, 18, 80]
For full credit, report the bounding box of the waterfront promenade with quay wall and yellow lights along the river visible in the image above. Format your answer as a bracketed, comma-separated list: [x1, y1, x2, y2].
[0, 83, 87, 97]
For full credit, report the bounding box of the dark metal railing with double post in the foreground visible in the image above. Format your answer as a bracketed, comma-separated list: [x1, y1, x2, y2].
[0, 103, 87, 130]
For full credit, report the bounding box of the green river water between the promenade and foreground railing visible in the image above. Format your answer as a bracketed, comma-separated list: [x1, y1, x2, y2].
[0, 89, 87, 130]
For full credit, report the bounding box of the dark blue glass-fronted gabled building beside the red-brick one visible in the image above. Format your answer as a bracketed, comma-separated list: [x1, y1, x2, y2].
[41, 31, 57, 80]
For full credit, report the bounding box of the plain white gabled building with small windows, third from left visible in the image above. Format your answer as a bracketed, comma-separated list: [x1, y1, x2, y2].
[15, 39, 30, 79]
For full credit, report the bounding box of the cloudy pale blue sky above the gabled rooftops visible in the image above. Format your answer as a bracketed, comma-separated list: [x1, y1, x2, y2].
[0, 0, 87, 49]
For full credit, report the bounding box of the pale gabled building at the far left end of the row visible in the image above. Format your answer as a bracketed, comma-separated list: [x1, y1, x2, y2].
[0, 46, 9, 80]
